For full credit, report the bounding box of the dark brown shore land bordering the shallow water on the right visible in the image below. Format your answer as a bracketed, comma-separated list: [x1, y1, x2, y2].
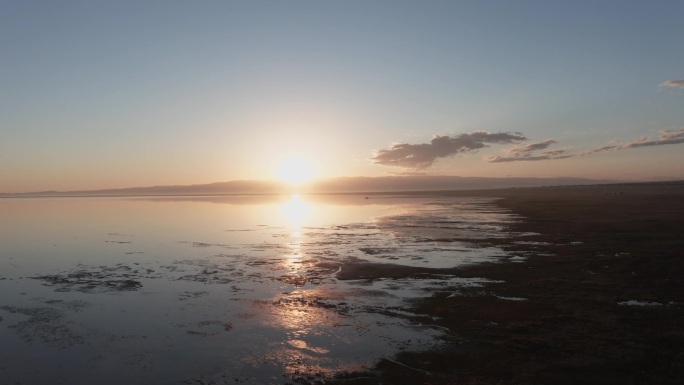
[332, 182, 684, 384]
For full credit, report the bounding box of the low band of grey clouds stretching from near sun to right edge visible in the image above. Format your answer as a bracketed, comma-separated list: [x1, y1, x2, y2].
[371, 127, 684, 170]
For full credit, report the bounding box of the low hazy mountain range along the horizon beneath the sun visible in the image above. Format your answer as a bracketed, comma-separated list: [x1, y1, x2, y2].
[0, 176, 618, 197]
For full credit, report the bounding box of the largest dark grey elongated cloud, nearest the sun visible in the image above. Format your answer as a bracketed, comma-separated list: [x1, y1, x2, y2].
[371, 131, 527, 170]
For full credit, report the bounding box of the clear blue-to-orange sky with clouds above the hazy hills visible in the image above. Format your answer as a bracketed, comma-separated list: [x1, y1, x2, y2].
[0, 0, 684, 192]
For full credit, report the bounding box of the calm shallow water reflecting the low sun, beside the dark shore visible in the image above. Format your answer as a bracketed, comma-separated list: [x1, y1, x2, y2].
[0, 195, 516, 384]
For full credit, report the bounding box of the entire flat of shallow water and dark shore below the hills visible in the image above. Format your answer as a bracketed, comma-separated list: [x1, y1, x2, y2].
[0, 183, 684, 384]
